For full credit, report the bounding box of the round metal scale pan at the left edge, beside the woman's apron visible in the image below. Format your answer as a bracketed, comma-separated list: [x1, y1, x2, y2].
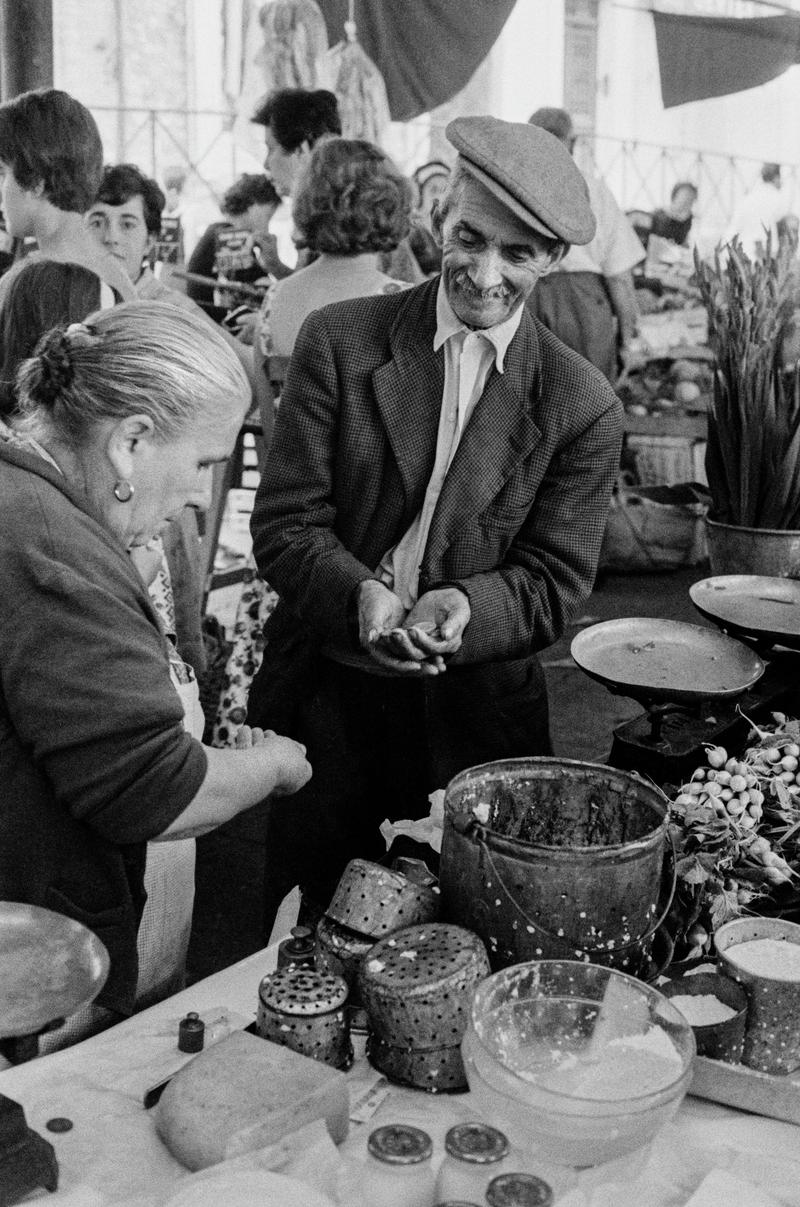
[0, 902, 109, 1039]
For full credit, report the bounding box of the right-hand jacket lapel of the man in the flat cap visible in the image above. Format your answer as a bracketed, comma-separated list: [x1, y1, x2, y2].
[425, 314, 542, 565]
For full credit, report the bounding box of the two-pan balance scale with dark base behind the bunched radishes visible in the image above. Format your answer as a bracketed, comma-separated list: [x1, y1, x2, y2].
[571, 575, 800, 785]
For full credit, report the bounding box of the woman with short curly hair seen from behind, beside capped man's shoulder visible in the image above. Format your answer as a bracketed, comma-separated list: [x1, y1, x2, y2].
[214, 138, 413, 745]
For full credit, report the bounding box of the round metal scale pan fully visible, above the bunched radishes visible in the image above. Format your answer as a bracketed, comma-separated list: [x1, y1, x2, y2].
[571, 617, 765, 709]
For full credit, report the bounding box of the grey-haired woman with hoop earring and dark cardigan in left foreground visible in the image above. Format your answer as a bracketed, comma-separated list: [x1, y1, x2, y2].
[0, 302, 310, 1031]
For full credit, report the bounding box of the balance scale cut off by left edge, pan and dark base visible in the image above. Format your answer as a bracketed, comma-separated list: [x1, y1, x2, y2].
[0, 902, 109, 1207]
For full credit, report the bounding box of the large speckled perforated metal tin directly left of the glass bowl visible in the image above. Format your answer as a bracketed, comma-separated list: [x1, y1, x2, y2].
[358, 922, 490, 1050]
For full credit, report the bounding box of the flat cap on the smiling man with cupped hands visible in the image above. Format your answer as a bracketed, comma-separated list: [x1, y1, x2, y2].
[444, 117, 596, 244]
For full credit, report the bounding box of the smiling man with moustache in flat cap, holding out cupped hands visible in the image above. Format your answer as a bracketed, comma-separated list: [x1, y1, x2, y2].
[249, 117, 621, 920]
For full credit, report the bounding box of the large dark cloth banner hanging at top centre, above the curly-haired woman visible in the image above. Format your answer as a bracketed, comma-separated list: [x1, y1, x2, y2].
[317, 0, 515, 122]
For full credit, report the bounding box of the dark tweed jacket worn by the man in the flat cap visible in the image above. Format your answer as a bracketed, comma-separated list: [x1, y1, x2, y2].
[252, 278, 621, 721]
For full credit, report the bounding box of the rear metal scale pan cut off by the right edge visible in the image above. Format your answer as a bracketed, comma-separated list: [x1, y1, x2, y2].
[689, 575, 800, 649]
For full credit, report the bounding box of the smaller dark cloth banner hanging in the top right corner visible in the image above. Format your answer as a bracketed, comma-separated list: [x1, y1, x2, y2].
[653, 12, 800, 109]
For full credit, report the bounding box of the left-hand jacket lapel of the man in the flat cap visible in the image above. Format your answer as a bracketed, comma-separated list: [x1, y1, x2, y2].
[372, 278, 444, 505]
